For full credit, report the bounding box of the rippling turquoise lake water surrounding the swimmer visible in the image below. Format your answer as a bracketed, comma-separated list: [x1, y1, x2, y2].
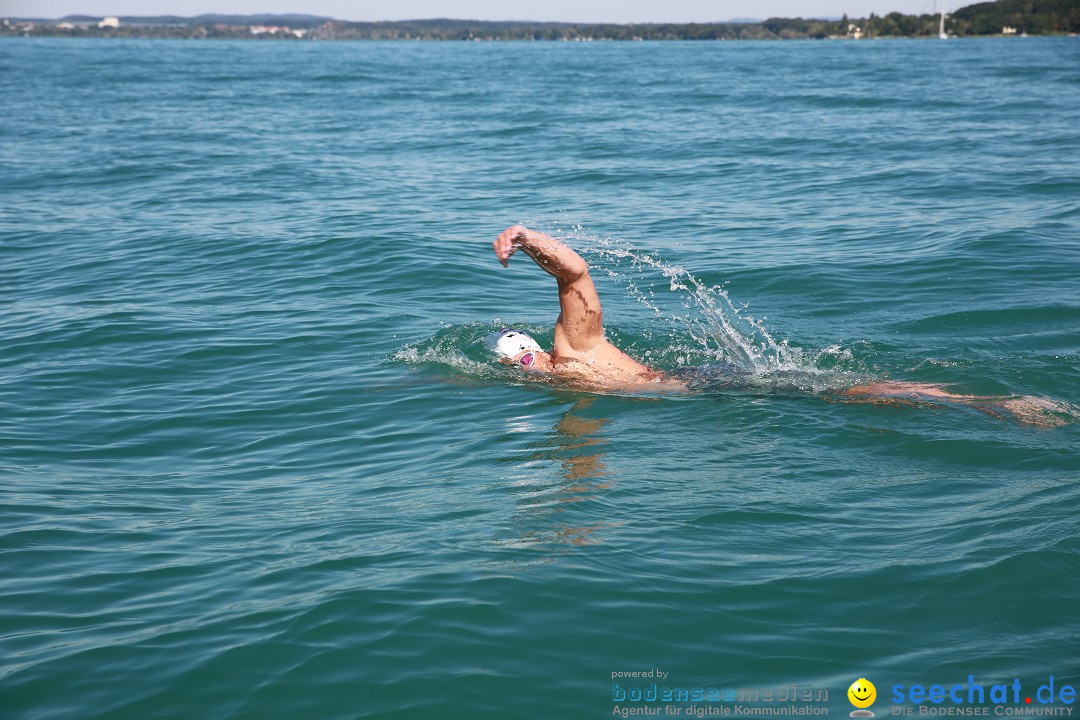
[0, 38, 1080, 720]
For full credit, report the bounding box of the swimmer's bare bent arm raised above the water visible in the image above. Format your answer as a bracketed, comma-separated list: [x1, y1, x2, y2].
[495, 225, 604, 352]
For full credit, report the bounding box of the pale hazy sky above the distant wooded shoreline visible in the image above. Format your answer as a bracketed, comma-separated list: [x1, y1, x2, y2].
[8, 0, 954, 23]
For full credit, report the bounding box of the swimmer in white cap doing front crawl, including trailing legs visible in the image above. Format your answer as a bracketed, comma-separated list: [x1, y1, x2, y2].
[489, 225, 1069, 425]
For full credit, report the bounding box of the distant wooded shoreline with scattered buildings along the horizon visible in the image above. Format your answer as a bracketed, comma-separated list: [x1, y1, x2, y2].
[0, 0, 1080, 42]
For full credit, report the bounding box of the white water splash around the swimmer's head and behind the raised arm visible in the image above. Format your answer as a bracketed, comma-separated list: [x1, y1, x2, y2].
[393, 226, 870, 393]
